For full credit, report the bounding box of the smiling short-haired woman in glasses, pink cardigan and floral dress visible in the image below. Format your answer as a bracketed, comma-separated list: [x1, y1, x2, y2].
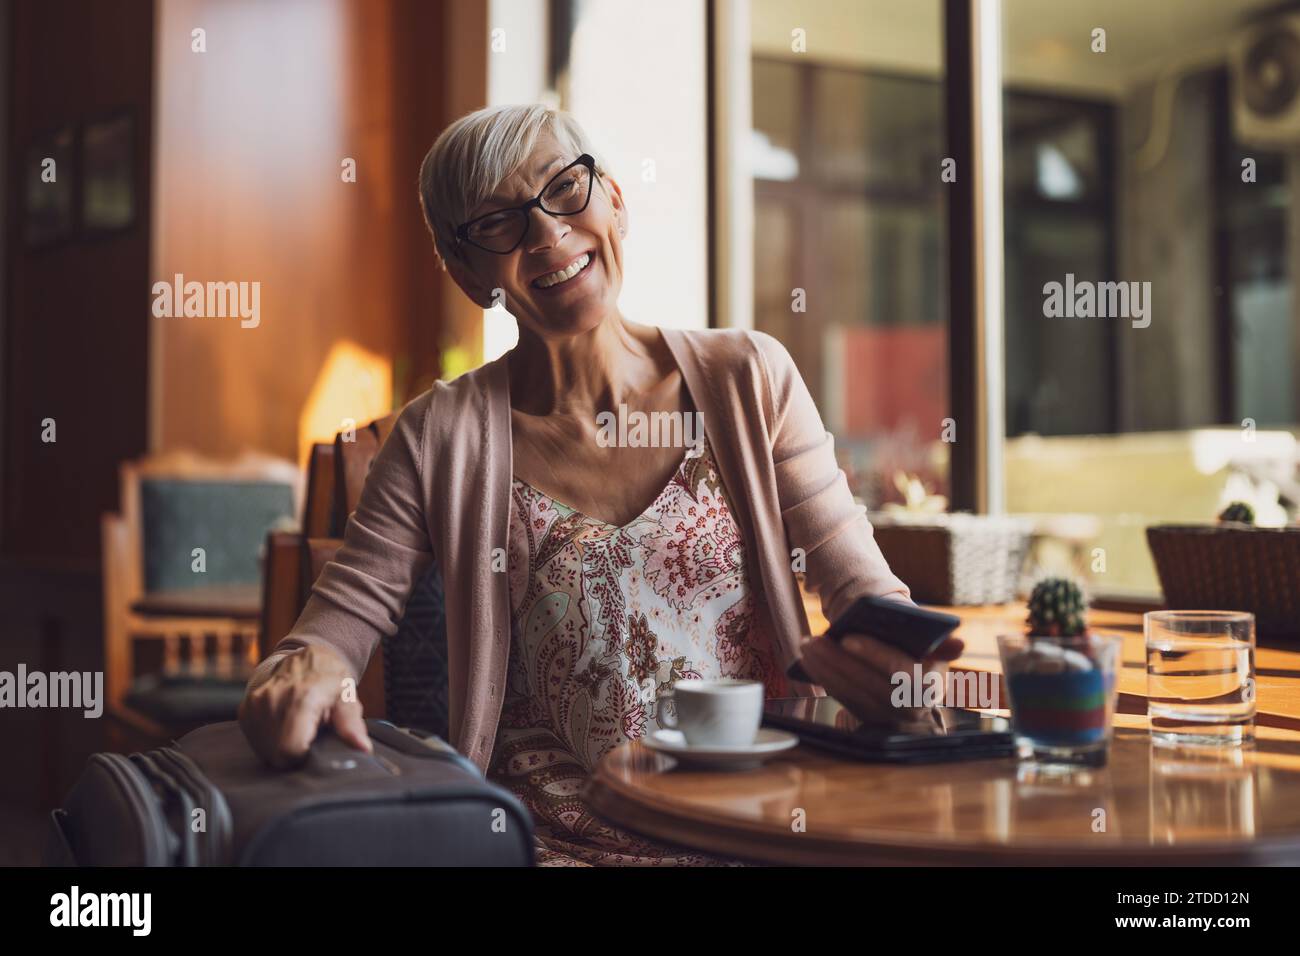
[241, 107, 961, 864]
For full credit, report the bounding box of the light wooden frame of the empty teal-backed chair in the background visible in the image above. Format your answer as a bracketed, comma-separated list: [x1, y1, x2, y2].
[100, 451, 302, 740]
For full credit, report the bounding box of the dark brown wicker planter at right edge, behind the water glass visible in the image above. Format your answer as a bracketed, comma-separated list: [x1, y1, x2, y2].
[1147, 524, 1300, 640]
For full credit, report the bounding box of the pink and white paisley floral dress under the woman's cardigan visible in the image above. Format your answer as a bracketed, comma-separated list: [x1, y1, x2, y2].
[489, 441, 788, 866]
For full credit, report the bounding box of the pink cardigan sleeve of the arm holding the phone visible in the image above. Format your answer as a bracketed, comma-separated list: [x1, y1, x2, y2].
[750, 332, 911, 629]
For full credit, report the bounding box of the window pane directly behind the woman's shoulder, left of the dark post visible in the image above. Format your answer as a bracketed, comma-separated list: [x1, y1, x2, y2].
[750, 0, 949, 507]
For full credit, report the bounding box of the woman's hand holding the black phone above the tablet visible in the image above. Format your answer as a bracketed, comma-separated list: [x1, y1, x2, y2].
[802, 633, 965, 723]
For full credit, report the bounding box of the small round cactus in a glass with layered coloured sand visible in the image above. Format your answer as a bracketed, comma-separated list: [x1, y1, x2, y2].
[998, 578, 1121, 766]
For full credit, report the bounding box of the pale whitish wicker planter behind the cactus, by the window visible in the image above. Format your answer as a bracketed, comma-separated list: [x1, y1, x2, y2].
[871, 514, 1034, 605]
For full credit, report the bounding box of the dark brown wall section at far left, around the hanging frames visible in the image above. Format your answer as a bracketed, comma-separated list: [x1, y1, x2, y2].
[0, 0, 153, 570]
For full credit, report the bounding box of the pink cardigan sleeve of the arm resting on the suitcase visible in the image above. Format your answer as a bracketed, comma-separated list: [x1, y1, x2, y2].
[250, 395, 433, 688]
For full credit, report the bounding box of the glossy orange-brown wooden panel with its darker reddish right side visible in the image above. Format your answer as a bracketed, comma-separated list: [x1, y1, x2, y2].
[151, 0, 486, 457]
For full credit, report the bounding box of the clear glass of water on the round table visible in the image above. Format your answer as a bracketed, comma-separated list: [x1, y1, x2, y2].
[1143, 611, 1255, 747]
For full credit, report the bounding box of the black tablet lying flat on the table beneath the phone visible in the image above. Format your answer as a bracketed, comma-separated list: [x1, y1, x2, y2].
[763, 697, 1017, 763]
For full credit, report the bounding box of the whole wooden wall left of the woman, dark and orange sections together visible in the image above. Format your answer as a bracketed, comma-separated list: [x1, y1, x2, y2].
[0, 0, 488, 568]
